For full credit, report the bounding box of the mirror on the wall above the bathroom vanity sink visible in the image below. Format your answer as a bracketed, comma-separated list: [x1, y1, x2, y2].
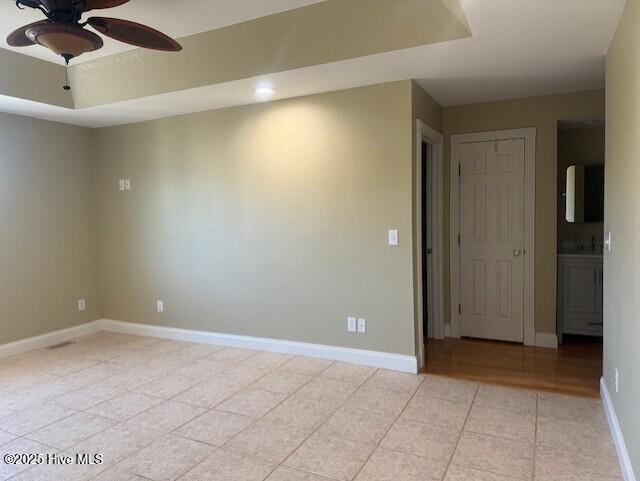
[564, 165, 604, 224]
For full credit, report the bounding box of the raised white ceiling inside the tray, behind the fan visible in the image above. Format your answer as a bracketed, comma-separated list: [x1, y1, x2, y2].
[0, 0, 323, 63]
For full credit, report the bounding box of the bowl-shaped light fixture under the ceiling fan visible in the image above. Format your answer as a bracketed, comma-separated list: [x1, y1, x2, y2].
[25, 23, 103, 58]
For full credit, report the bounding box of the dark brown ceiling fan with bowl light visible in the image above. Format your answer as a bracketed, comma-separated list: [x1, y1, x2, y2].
[7, 0, 182, 80]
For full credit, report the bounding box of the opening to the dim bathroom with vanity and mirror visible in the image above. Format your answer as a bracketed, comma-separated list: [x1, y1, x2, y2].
[556, 119, 606, 362]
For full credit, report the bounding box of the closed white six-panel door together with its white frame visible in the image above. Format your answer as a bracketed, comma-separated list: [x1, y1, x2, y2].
[450, 128, 536, 347]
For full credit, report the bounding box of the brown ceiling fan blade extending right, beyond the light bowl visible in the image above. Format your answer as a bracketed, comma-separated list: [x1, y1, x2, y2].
[87, 17, 182, 52]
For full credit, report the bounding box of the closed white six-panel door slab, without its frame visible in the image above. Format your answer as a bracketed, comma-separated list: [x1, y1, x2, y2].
[460, 139, 525, 342]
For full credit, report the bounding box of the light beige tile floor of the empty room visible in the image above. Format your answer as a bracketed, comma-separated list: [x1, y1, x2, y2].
[0, 332, 622, 481]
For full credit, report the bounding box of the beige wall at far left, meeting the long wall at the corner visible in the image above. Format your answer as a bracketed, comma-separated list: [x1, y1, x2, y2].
[0, 113, 101, 345]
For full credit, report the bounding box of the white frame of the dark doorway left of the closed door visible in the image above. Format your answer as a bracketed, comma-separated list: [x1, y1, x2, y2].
[414, 119, 444, 367]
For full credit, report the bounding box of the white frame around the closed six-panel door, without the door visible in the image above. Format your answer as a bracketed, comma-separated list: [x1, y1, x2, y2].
[449, 127, 536, 346]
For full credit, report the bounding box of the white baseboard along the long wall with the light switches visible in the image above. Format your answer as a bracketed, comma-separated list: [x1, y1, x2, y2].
[101, 319, 418, 374]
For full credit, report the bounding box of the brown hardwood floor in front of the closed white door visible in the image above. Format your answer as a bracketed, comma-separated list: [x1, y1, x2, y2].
[423, 336, 602, 397]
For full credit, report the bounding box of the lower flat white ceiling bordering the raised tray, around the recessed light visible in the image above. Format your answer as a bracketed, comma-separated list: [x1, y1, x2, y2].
[0, 0, 626, 127]
